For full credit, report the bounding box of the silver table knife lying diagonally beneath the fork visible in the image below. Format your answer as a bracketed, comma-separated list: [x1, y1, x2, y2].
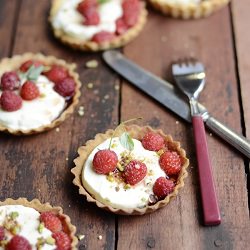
[103, 50, 250, 158]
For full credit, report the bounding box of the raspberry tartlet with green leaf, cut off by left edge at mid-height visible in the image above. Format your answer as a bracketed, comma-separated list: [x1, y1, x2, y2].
[0, 53, 81, 135]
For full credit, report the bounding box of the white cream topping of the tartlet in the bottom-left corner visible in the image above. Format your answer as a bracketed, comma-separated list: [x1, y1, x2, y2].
[0, 205, 56, 250]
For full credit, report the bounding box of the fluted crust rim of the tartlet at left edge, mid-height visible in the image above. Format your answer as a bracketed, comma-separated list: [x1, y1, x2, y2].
[0, 53, 81, 135]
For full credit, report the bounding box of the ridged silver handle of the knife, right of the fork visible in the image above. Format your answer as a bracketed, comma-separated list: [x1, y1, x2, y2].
[205, 116, 250, 158]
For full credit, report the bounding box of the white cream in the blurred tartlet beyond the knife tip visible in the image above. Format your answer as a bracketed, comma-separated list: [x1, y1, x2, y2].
[52, 0, 123, 41]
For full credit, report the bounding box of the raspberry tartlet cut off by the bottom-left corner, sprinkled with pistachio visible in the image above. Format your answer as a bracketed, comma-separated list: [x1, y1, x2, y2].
[0, 198, 78, 250]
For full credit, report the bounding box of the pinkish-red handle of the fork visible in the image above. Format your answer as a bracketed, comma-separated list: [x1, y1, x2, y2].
[192, 116, 221, 226]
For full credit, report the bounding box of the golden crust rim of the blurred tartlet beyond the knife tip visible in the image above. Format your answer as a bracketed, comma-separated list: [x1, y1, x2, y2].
[49, 0, 147, 52]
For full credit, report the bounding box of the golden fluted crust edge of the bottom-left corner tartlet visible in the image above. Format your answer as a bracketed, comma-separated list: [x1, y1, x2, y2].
[0, 198, 78, 250]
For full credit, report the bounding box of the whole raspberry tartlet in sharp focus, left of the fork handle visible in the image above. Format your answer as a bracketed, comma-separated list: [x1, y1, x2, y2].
[71, 125, 189, 215]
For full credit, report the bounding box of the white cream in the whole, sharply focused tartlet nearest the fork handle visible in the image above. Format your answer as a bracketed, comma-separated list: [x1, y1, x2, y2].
[82, 137, 166, 209]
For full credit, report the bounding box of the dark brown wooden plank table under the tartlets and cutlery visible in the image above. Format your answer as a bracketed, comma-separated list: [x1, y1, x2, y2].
[0, 0, 250, 250]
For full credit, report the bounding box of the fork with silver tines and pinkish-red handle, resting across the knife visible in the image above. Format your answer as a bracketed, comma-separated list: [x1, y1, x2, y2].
[172, 61, 221, 226]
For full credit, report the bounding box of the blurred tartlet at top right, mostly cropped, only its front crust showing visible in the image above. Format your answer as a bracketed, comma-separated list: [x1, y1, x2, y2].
[148, 0, 230, 19]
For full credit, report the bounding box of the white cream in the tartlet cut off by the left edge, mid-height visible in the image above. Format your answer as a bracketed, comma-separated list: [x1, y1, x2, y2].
[0, 75, 66, 130]
